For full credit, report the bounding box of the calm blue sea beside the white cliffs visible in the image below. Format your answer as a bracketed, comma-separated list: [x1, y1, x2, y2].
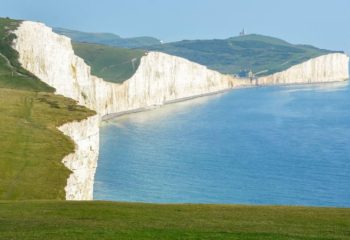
[94, 82, 350, 207]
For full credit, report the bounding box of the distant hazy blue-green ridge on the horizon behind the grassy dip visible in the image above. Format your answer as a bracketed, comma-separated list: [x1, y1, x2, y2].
[53, 28, 160, 48]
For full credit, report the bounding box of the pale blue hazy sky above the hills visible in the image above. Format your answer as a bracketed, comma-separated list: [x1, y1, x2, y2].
[0, 0, 350, 53]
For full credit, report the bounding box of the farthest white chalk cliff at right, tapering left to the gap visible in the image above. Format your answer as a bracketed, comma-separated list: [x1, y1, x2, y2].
[257, 53, 349, 85]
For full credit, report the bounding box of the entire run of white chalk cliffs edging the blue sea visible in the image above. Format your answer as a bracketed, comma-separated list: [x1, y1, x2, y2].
[13, 21, 349, 200]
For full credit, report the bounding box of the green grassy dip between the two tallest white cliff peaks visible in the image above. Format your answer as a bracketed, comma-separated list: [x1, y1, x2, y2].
[73, 42, 145, 83]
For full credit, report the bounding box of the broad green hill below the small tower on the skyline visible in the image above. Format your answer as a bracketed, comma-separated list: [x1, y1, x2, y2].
[147, 34, 336, 75]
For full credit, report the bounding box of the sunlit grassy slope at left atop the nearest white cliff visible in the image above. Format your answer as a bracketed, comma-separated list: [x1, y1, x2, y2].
[0, 18, 94, 199]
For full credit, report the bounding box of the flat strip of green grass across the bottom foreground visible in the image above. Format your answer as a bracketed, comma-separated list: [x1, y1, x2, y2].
[0, 202, 350, 240]
